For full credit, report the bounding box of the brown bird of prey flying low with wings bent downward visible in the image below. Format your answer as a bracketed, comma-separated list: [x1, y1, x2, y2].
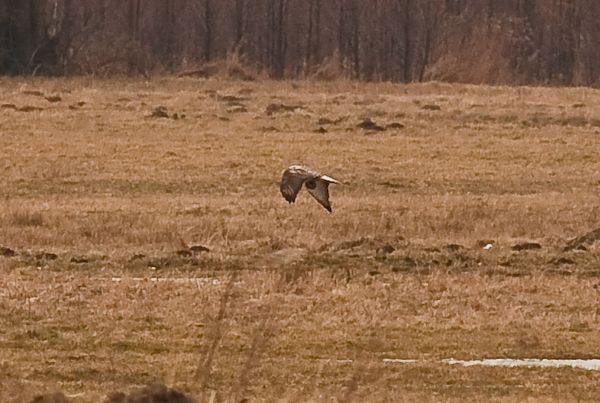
[279, 165, 340, 213]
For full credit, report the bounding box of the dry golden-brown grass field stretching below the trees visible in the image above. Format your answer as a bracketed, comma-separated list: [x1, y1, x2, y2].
[0, 78, 600, 402]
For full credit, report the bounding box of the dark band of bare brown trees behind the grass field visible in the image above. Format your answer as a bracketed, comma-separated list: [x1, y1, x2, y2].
[0, 0, 600, 85]
